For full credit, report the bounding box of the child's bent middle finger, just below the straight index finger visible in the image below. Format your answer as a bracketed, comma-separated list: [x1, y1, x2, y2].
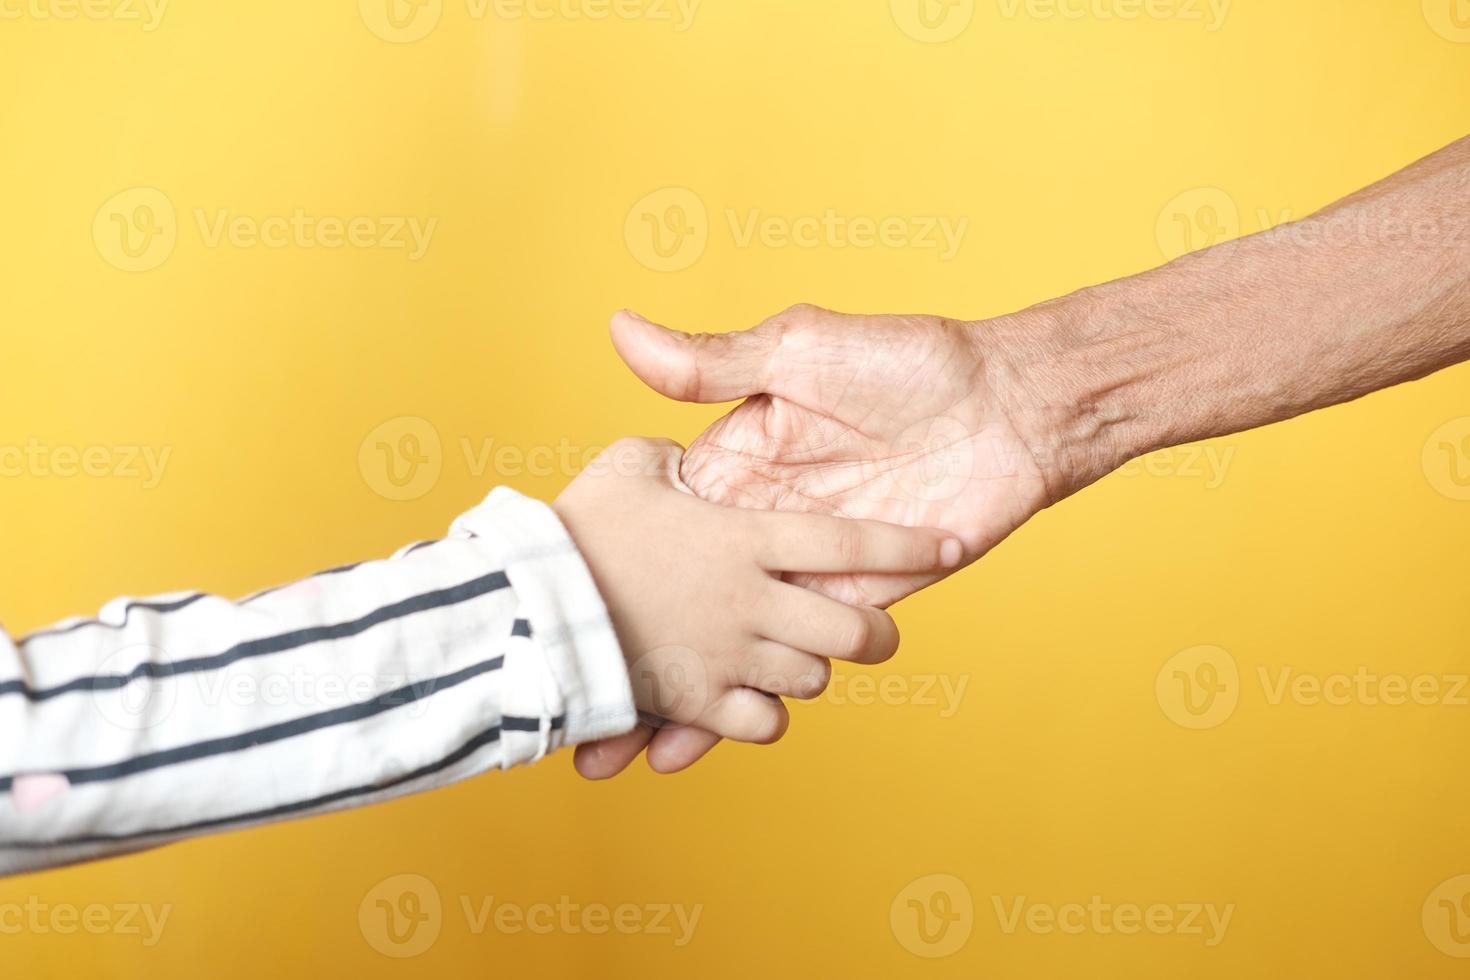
[756, 582, 898, 664]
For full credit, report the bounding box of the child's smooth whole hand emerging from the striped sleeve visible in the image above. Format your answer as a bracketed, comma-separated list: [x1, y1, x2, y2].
[554, 439, 963, 743]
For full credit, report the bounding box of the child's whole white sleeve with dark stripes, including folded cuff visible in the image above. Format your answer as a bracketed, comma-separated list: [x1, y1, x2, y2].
[0, 488, 635, 874]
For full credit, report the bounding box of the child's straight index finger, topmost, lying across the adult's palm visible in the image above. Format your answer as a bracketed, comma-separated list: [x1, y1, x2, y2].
[751, 513, 964, 574]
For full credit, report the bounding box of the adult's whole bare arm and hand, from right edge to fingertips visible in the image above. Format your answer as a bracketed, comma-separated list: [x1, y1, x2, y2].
[579, 138, 1470, 774]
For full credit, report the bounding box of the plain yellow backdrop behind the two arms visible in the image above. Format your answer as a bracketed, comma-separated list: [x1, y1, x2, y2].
[0, 0, 1470, 980]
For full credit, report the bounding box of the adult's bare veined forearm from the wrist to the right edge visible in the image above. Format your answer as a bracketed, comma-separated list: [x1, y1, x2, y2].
[999, 138, 1470, 498]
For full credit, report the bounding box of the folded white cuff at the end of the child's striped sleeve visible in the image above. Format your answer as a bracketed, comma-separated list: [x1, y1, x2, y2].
[451, 486, 638, 765]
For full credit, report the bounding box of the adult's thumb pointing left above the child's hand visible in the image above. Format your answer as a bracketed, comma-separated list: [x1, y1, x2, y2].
[612, 310, 772, 403]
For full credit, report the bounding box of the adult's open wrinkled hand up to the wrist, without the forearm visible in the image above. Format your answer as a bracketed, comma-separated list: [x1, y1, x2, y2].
[576, 307, 1053, 779]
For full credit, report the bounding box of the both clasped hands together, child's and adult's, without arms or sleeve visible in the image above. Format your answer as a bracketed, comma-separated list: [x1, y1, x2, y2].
[556, 307, 1099, 779]
